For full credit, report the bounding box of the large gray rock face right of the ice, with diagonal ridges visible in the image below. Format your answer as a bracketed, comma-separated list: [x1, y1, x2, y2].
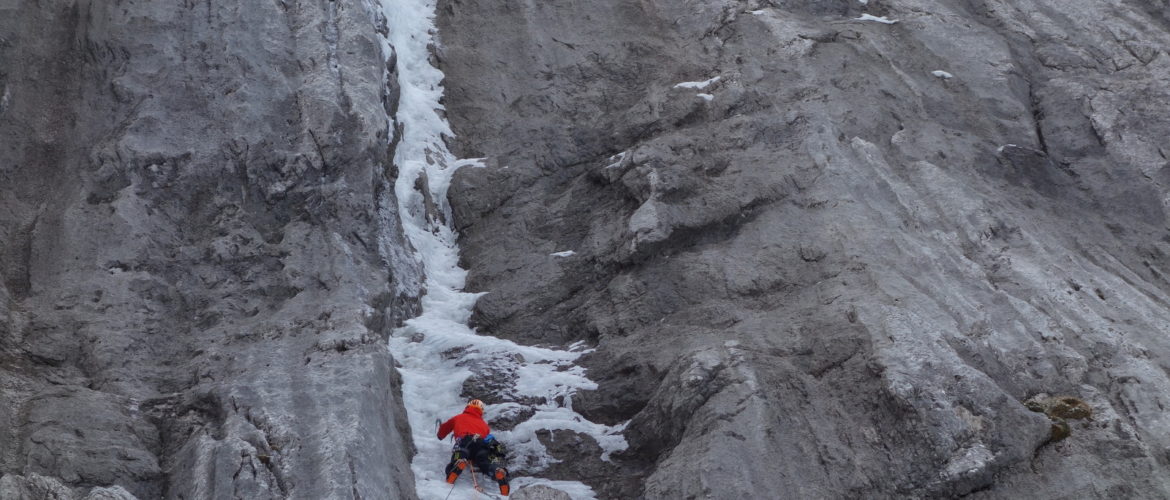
[438, 0, 1170, 499]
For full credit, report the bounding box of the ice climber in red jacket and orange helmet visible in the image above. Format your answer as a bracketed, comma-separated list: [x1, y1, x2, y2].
[439, 399, 509, 496]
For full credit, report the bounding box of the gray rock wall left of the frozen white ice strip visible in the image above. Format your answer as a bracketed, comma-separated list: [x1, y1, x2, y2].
[0, 1, 420, 499]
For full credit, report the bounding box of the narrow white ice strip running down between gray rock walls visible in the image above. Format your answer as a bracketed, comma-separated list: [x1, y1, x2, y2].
[378, 0, 626, 500]
